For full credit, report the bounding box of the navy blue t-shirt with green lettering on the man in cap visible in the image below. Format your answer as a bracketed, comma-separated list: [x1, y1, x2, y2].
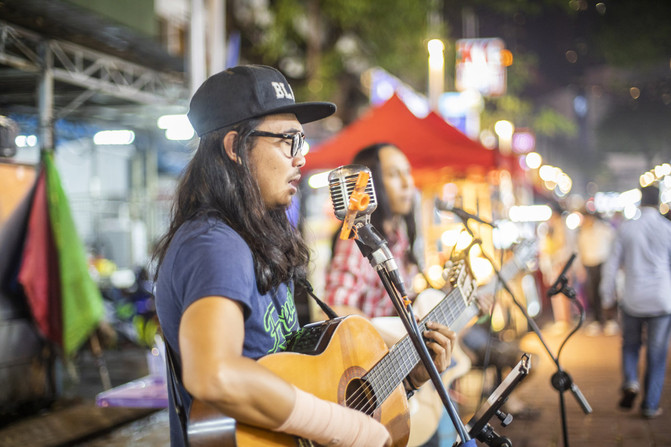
[156, 218, 298, 446]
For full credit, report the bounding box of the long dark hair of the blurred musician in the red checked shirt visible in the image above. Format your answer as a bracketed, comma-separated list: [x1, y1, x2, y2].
[331, 142, 418, 264]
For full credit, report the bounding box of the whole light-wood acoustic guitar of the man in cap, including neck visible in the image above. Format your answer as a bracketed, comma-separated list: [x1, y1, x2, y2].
[187, 260, 478, 447]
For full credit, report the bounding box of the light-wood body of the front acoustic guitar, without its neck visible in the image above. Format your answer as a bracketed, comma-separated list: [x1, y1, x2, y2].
[188, 316, 410, 447]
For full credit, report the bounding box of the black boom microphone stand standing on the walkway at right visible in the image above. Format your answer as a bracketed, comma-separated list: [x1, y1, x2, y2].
[441, 208, 592, 447]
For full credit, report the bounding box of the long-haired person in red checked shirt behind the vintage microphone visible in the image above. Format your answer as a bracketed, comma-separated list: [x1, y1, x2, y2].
[325, 143, 454, 447]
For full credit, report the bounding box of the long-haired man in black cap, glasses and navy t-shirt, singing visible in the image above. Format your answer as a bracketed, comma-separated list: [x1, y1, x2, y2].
[156, 65, 453, 446]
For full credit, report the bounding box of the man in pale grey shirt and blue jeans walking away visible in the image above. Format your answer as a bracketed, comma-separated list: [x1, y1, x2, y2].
[601, 185, 671, 418]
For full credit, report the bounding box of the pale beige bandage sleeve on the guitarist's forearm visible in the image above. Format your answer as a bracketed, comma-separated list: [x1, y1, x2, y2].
[276, 387, 390, 447]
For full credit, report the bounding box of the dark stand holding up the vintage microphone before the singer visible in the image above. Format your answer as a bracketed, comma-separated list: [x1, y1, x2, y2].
[355, 223, 476, 447]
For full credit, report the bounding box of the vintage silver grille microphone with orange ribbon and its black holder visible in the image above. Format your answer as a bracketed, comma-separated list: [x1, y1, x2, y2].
[329, 165, 407, 297]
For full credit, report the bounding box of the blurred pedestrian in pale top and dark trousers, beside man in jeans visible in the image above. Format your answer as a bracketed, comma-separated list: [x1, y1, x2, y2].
[578, 212, 617, 335]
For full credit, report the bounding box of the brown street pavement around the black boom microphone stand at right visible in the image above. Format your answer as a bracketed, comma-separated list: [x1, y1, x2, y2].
[492, 322, 671, 447]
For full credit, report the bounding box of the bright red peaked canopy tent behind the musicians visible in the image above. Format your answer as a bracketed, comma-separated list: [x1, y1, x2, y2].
[305, 95, 497, 185]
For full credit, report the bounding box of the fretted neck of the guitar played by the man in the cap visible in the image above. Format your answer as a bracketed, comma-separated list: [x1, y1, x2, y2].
[363, 288, 478, 408]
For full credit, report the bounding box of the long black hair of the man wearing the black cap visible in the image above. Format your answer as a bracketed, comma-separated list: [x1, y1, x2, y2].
[154, 119, 310, 293]
